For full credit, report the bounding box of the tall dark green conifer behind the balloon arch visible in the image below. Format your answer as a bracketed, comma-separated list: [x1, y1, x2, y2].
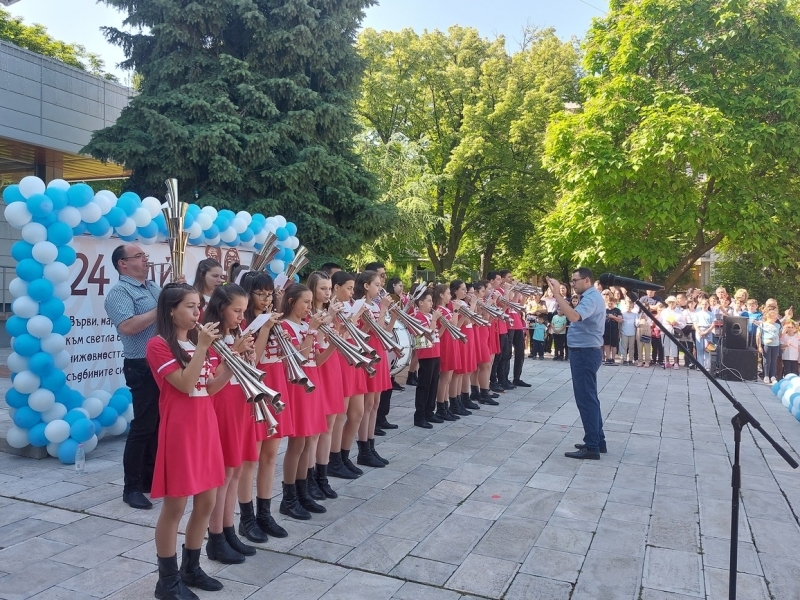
[85, 0, 391, 255]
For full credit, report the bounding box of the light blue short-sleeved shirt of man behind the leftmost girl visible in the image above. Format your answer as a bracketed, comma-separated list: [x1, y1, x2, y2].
[104, 275, 161, 358]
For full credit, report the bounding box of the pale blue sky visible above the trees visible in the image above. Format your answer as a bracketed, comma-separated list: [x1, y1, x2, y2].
[6, 0, 608, 83]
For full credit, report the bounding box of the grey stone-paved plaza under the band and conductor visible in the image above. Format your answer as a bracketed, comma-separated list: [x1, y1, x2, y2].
[0, 359, 800, 600]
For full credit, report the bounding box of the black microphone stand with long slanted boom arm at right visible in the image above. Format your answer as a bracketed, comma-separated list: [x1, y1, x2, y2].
[627, 290, 800, 600]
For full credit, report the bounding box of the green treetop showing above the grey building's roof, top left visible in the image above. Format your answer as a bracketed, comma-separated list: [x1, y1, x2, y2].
[0, 8, 117, 81]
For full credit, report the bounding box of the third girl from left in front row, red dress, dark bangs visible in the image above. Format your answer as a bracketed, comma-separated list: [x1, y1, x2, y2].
[239, 271, 289, 543]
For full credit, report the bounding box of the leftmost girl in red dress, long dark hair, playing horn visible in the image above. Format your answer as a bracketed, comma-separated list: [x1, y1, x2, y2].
[146, 283, 231, 599]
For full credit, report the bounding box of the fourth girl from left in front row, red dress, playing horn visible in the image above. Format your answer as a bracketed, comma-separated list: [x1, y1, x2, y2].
[280, 283, 327, 520]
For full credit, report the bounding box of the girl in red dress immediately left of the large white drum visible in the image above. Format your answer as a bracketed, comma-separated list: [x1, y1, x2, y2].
[353, 271, 394, 469]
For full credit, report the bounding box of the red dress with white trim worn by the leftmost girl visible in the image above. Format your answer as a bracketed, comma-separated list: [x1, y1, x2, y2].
[146, 337, 225, 498]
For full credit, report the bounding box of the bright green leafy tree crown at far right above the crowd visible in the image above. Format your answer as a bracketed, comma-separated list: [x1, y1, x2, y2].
[544, 0, 800, 288]
